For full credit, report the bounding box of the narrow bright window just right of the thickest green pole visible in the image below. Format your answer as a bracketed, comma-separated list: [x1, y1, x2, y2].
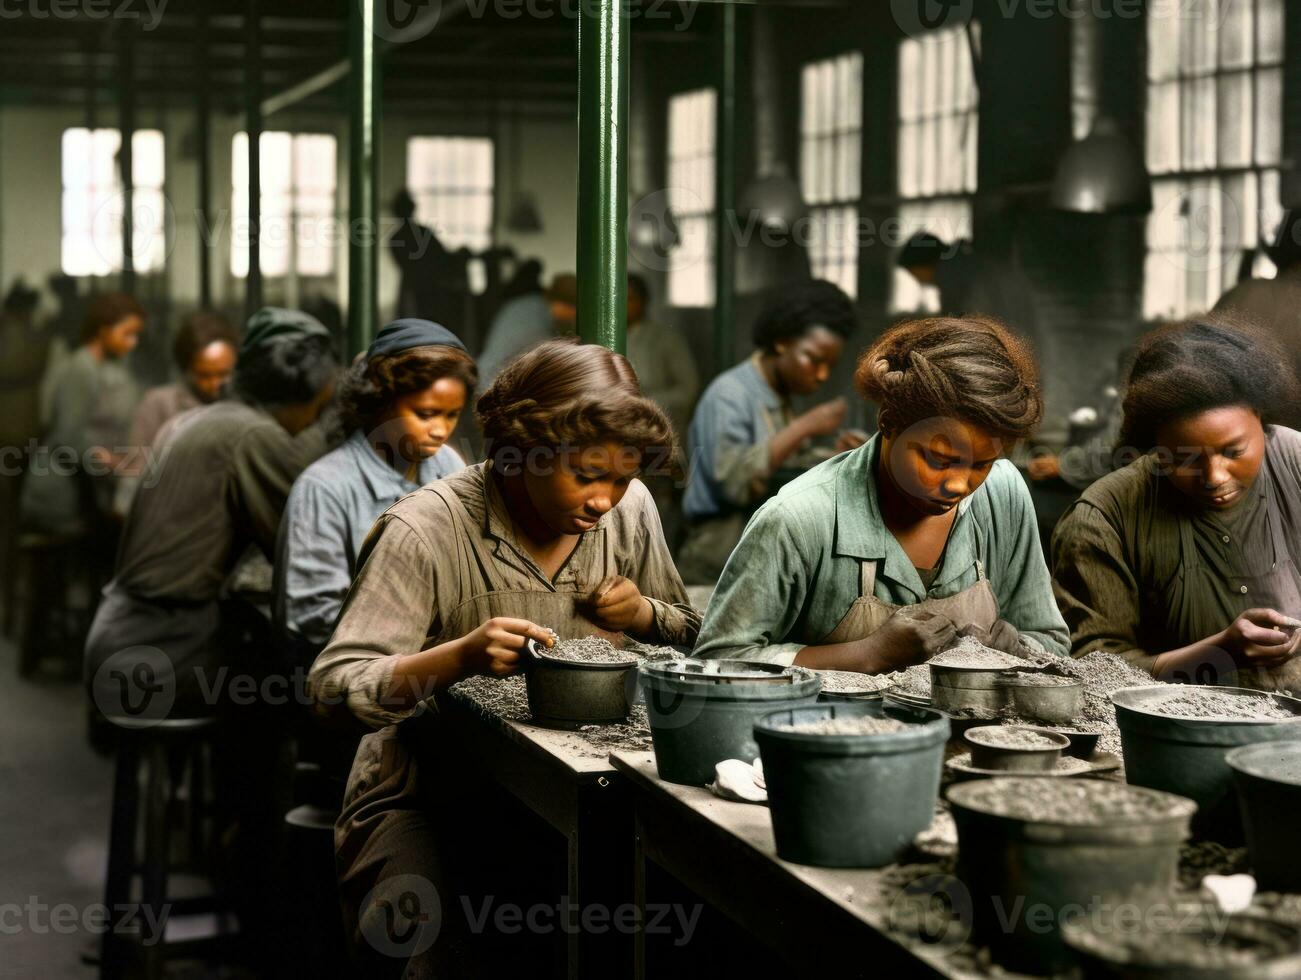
[669, 88, 718, 306]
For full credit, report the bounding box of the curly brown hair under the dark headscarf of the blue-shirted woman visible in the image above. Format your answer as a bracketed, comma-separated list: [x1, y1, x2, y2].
[338, 344, 479, 429]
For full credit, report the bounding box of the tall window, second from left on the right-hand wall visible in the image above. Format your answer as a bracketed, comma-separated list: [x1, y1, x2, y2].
[800, 52, 863, 295]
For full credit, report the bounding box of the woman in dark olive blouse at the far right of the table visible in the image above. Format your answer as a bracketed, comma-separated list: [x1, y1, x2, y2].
[1053, 318, 1301, 691]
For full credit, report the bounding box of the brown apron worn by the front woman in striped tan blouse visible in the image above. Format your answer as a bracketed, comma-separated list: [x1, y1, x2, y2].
[334, 487, 622, 977]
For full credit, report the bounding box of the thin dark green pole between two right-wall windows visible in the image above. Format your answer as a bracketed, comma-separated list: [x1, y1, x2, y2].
[714, 4, 736, 374]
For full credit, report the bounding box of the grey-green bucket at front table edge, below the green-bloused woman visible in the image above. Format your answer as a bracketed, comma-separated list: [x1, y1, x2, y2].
[755, 703, 948, 868]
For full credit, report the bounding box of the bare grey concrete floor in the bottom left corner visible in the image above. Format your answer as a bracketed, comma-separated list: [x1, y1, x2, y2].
[0, 640, 113, 980]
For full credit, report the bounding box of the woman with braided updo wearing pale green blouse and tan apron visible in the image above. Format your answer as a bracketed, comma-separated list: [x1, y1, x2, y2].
[696, 316, 1067, 674]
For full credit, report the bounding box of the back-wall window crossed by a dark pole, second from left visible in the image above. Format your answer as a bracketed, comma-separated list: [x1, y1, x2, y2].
[230, 133, 340, 279]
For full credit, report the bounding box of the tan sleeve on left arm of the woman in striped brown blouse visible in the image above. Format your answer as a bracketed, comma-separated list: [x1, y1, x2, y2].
[308, 514, 438, 729]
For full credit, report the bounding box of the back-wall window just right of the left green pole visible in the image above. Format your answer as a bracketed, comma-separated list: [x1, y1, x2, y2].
[407, 137, 493, 251]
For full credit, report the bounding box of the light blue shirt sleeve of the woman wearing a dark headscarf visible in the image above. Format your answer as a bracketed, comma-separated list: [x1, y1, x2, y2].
[276, 474, 353, 649]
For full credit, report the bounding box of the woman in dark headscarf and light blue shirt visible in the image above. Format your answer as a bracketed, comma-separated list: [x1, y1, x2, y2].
[275, 319, 477, 662]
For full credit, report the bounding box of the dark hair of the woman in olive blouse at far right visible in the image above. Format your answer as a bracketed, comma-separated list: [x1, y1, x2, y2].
[1120, 314, 1297, 452]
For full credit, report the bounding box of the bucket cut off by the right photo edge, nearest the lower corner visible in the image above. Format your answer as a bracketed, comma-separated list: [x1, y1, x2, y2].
[1226, 742, 1301, 895]
